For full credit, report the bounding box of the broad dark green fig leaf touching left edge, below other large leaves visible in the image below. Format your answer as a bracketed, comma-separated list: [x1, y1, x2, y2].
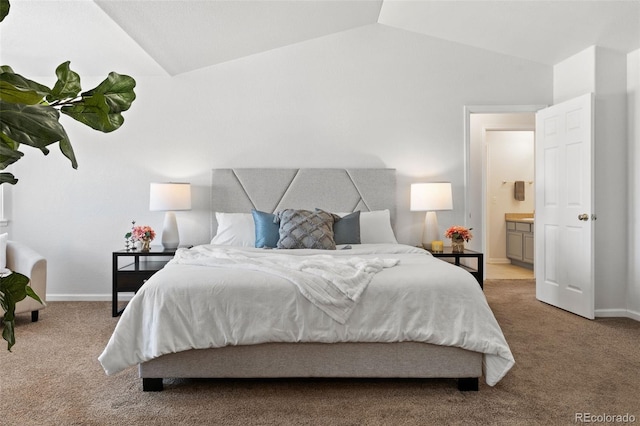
[0, 100, 67, 150]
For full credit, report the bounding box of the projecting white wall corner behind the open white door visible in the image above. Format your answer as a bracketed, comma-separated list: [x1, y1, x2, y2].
[554, 47, 628, 316]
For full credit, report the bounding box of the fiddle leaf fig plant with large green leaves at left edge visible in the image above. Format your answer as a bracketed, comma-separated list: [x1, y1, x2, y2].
[0, 0, 136, 350]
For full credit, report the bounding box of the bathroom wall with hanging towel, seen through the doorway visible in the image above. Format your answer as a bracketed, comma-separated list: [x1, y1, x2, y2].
[485, 130, 535, 263]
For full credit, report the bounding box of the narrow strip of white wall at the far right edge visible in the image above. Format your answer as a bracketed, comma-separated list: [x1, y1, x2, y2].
[626, 50, 640, 321]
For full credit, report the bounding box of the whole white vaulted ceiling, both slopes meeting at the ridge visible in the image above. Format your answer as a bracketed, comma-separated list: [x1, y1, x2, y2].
[96, 0, 640, 74]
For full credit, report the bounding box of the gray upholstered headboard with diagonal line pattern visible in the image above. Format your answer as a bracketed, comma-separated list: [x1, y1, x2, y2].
[211, 168, 396, 234]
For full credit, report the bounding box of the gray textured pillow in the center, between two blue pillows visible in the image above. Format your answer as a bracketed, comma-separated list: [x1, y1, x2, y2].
[276, 209, 336, 250]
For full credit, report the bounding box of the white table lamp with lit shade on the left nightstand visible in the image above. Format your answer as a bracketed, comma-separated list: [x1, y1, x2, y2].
[149, 182, 191, 249]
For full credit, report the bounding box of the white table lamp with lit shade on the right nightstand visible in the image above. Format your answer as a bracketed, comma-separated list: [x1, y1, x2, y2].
[411, 182, 453, 250]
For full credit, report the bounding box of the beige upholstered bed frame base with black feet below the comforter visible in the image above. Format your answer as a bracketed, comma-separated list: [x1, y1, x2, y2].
[139, 342, 482, 392]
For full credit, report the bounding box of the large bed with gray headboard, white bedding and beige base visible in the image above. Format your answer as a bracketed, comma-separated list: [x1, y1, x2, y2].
[99, 169, 514, 391]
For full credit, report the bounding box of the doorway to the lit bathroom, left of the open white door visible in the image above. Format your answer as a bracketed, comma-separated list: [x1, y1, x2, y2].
[466, 106, 541, 279]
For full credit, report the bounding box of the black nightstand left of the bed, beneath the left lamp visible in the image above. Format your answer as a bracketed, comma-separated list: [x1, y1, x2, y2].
[111, 246, 176, 317]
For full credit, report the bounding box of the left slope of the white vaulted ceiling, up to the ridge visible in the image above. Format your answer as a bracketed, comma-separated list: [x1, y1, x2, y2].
[94, 0, 382, 75]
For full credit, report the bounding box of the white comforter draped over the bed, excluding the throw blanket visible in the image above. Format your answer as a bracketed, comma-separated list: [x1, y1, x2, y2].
[99, 244, 514, 386]
